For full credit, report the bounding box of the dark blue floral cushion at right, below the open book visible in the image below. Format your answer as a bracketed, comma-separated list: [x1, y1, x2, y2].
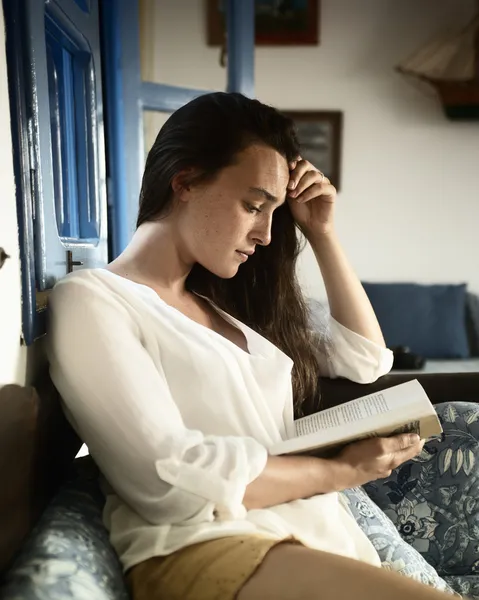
[364, 402, 479, 598]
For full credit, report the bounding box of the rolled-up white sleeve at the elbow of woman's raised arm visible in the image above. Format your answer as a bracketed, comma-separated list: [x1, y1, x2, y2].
[313, 315, 394, 383]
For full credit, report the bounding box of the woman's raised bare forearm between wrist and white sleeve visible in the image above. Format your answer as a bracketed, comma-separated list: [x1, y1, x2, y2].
[308, 232, 385, 346]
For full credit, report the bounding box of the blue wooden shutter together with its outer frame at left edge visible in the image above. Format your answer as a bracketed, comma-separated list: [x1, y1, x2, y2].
[3, 0, 107, 344]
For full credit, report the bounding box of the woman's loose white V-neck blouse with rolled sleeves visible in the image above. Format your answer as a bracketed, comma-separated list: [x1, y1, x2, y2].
[48, 269, 392, 570]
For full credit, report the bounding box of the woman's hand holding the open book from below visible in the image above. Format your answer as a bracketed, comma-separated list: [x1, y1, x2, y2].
[333, 434, 425, 487]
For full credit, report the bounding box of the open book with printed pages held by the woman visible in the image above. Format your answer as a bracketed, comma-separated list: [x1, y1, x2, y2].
[269, 379, 442, 456]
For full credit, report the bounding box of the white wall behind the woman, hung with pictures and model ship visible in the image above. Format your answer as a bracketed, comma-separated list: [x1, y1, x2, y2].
[146, 0, 479, 298]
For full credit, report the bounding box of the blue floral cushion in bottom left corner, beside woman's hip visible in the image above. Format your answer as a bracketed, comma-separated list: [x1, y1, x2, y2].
[0, 458, 129, 600]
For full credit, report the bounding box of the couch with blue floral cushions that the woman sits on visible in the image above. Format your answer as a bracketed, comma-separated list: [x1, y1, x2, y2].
[0, 373, 479, 600]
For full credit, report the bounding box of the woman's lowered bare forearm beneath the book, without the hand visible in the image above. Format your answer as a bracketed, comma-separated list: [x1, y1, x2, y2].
[243, 456, 352, 510]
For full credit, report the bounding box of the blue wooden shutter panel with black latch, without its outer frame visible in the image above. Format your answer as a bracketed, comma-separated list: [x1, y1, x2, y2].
[26, 0, 107, 291]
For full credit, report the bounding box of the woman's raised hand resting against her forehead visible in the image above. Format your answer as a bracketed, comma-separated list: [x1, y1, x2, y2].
[287, 157, 336, 237]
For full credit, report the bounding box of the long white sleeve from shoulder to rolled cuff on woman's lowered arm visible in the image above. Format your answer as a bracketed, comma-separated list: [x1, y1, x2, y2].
[48, 281, 267, 524]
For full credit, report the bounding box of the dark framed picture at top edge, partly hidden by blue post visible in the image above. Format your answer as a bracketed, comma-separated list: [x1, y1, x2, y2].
[206, 0, 320, 46]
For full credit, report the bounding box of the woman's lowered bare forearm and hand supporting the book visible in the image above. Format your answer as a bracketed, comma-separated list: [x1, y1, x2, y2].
[243, 434, 424, 509]
